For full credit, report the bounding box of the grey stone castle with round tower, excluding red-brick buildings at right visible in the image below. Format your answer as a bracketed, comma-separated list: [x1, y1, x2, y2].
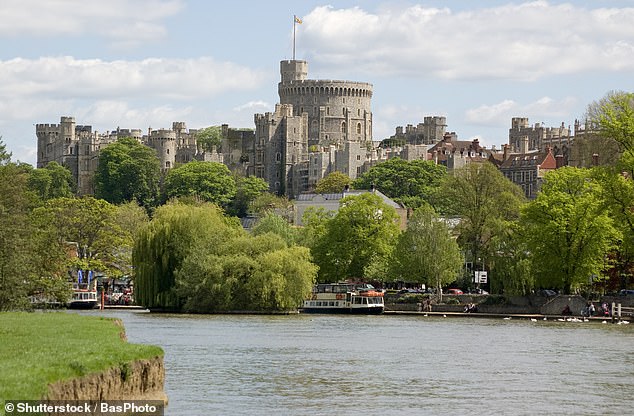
[36, 60, 430, 198]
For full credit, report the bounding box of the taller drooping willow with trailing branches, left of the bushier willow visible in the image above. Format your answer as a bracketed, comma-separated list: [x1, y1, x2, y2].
[132, 203, 243, 310]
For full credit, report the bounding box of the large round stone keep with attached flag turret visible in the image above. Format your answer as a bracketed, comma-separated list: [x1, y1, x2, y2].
[278, 60, 372, 148]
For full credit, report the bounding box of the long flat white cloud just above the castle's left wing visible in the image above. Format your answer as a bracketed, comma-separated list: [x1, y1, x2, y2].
[0, 57, 264, 100]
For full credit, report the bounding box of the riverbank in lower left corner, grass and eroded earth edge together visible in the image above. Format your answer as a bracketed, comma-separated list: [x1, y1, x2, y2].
[0, 312, 165, 401]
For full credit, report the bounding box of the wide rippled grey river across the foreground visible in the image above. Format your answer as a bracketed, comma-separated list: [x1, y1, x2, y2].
[75, 311, 634, 416]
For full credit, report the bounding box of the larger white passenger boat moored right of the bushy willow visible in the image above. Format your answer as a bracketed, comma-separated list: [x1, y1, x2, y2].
[302, 283, 385, 314]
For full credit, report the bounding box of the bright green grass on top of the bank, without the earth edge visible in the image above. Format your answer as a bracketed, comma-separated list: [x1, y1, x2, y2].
[0, 312, 163, 402]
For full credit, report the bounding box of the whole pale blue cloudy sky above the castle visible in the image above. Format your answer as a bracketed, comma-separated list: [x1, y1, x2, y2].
[0, 0, 634, 165]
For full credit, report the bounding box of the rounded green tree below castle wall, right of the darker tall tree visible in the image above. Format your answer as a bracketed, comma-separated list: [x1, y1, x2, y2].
[164, 161, 236, 206]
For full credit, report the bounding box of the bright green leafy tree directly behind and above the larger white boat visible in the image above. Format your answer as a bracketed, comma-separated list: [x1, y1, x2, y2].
[311, 193, 400, 282]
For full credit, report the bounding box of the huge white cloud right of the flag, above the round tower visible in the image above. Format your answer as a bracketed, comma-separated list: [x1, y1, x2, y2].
[299, 1, 634, 81]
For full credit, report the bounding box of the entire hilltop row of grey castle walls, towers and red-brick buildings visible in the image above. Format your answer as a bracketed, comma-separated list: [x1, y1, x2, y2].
[36, 60, 604, 199]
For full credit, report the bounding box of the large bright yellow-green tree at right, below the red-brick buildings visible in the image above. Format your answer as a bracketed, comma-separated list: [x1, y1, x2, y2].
[522, 167, 620, 293]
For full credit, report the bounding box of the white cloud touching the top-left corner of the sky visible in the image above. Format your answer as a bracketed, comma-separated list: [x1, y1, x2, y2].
[0, 0, 184, 44]
